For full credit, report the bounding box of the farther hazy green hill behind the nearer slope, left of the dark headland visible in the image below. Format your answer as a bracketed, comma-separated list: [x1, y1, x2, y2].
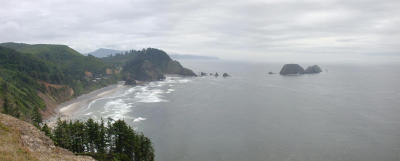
[0, 43, 117, 96]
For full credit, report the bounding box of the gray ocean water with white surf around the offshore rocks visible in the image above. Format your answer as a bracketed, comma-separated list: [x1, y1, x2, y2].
[70, 61, 400, 161]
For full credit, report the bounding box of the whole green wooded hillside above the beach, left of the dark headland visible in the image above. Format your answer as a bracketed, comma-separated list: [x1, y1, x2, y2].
[0, 43, 118, 123]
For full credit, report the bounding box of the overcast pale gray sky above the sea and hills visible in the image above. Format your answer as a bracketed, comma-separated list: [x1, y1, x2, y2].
[0, 0, 400, 61]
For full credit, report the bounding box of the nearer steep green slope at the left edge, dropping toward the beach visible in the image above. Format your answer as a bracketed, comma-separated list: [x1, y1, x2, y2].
[0, 47, 51, 122]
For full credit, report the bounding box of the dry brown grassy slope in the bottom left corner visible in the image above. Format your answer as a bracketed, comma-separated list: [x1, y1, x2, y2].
[0, 114, 94, 161]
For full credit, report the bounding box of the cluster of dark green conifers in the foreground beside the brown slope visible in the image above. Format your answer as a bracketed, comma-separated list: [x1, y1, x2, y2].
[42, 119, 154, 161]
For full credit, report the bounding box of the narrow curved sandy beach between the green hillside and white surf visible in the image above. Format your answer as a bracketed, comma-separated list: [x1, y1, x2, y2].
[43, 82, 129, 126]
